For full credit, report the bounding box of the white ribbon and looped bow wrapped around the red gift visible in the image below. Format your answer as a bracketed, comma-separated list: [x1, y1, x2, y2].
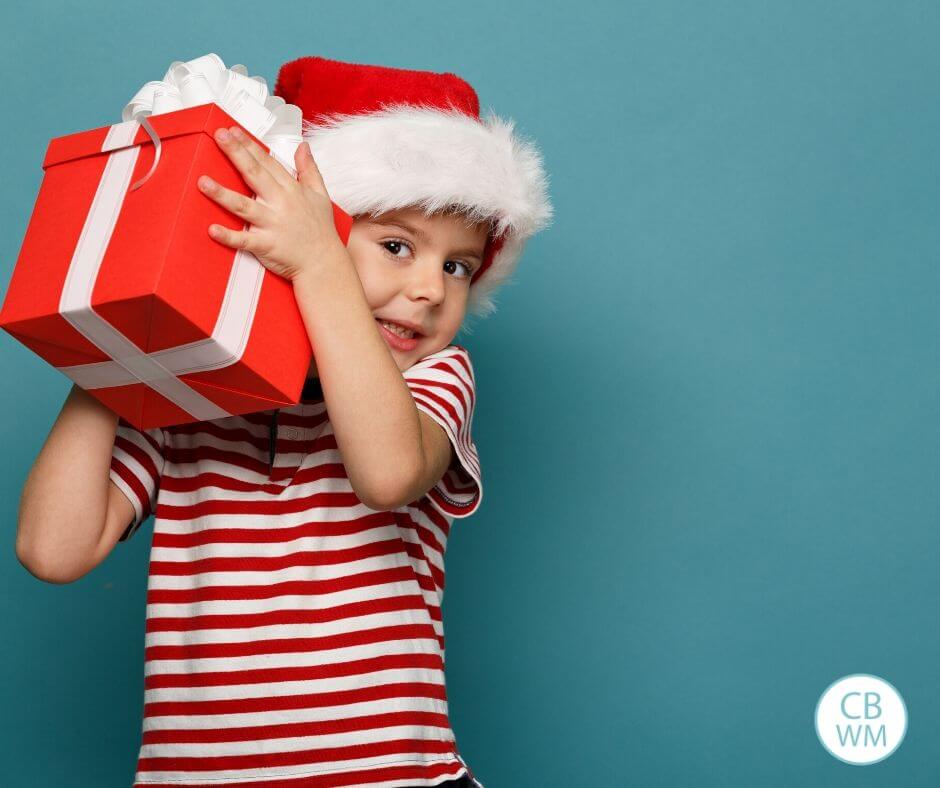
[59, 54, 301, 421]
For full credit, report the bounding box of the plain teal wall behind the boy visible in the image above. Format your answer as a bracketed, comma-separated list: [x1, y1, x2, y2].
[0, 0, 940, 788]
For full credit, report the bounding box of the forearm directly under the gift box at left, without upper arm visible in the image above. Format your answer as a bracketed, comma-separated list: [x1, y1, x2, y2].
[16, 386, 118, 564]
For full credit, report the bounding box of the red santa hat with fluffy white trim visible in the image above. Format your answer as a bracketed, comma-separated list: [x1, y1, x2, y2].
[274, 57, 552, 315]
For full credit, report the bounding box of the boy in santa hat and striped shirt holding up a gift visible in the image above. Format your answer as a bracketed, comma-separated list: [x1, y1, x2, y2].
[17, 58, 551, 788]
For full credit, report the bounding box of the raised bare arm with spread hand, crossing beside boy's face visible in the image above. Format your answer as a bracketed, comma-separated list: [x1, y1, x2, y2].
[198, 128, 450, 509]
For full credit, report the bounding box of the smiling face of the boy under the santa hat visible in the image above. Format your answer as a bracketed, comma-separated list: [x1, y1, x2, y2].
[347, 209, 487, 371]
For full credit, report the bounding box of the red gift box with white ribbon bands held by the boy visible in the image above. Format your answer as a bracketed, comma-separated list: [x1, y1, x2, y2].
[0, 104, 352, 429]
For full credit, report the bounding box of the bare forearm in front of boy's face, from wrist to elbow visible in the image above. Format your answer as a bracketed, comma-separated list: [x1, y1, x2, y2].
[294, 246, 424, 502]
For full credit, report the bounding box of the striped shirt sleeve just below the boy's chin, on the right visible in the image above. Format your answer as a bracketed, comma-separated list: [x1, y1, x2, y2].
[402, 345, 483, 517]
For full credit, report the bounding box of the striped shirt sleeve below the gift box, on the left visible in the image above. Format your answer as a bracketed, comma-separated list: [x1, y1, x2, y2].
[110, 419, 166, 542]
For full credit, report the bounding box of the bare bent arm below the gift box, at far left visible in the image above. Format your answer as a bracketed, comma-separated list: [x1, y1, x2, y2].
[16, 386, 134, 583]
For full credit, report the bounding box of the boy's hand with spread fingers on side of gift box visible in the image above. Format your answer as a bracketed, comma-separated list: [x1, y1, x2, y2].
[199, 127, 345, 281]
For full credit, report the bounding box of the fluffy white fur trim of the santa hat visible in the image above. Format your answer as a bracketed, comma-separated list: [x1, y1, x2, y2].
[304, 105, 552, 315]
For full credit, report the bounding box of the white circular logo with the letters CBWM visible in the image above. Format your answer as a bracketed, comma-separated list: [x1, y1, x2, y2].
[816, 673, 907, 766]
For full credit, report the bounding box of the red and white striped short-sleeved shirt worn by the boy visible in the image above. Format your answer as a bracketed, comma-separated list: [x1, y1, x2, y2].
[110, 345, 482, 788]
